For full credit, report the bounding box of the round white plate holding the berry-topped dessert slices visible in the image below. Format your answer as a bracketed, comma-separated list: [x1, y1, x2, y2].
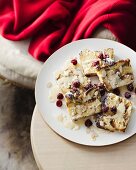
[35, 38, 136, 146]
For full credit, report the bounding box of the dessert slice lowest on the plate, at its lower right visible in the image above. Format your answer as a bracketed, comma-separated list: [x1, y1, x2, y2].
[96, 93, 132, 132]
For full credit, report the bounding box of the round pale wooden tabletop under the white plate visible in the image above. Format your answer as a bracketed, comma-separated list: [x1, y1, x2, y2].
[31, 107, 136, 170]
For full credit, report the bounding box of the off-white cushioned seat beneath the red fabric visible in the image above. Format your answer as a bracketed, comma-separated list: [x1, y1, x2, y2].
[0, 28, 117, 89]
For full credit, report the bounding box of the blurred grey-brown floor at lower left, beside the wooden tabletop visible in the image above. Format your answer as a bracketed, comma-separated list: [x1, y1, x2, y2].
[0, 79, 38, 170]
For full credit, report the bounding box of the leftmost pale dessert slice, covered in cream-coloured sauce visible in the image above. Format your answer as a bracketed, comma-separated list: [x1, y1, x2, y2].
[55, 61, 88, 94]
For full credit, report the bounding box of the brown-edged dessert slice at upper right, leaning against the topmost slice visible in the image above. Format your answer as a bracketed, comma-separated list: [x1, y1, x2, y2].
[96, 59, 134, 91]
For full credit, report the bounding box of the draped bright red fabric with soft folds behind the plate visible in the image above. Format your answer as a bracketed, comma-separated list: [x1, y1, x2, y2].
[0, 0, 136, 61]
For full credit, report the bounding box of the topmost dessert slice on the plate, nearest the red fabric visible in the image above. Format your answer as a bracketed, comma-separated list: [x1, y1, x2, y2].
[79, 48, 114, 76]
